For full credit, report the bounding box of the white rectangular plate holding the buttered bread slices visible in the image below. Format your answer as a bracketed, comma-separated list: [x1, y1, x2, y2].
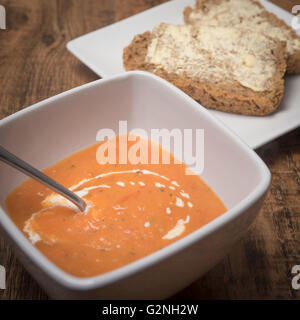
[67, 0, 300, 148]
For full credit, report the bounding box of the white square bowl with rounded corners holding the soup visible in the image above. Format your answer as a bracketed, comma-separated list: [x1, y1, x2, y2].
[0, 71, 270, 299]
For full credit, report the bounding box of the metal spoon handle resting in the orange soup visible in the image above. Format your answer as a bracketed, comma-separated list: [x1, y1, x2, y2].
[0, 146, 86, 211]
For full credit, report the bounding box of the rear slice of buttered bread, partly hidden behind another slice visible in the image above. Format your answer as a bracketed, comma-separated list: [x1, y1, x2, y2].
[184, 0, 300, 73]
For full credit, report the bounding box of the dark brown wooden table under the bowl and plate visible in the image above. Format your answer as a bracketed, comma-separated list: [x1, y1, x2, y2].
[0, 0, 300, 299]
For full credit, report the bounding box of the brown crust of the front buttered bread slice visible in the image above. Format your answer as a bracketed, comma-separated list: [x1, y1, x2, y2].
[123, 31, 286, 116]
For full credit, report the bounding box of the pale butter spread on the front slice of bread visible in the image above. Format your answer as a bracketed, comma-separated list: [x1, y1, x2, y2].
[146, 23, 276, 91]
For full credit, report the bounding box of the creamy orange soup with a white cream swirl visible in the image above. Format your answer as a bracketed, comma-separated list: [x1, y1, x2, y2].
[6, 137, 226, 277]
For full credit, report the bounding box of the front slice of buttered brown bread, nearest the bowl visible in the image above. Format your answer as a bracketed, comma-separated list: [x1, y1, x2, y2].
[123, 23, 286, 115]
